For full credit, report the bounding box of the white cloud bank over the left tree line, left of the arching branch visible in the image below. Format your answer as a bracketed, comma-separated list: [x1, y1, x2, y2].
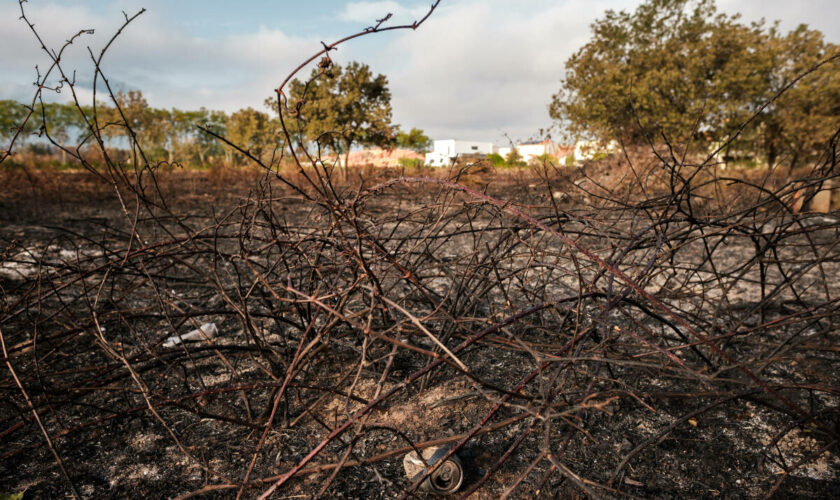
[0, 4, 320, 111]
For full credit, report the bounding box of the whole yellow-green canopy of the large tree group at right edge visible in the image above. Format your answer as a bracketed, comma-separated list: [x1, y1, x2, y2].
[549, 0, 840, 168]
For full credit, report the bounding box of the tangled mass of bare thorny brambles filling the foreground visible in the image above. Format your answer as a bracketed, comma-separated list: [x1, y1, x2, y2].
[0, 0, 840, 498]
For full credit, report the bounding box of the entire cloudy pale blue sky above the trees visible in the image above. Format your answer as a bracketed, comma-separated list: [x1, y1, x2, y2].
[0, 0, 840, 144]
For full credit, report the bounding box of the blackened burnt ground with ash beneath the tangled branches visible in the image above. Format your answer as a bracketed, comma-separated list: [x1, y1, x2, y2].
[0, 171, 840, 499]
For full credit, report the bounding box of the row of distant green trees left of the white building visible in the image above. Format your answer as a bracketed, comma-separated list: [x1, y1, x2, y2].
[0, 62, 431, 166]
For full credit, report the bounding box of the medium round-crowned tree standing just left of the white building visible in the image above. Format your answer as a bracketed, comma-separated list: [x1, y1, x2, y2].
[289, 62, 396, 171]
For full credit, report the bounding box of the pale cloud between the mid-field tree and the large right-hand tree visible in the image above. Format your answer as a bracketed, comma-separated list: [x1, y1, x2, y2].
[383, 0, 629, 142]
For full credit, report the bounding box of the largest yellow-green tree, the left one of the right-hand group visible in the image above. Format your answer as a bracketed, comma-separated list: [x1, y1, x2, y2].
[549, 0, 773, 146]
